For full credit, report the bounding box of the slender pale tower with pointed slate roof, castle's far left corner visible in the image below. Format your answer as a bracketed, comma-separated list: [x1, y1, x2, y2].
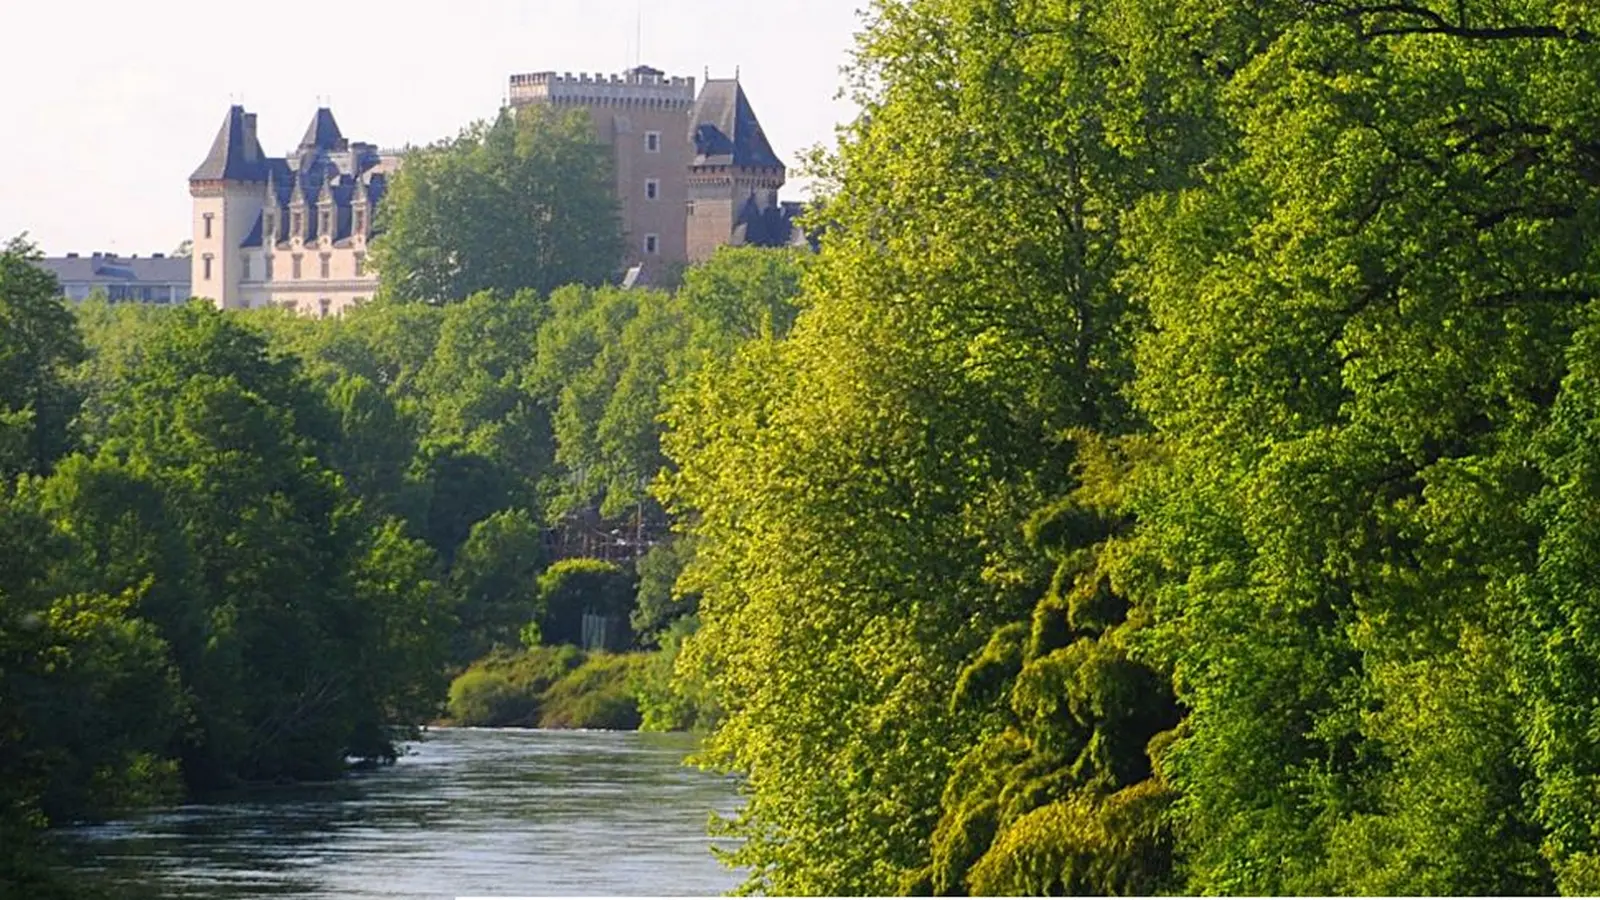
[189, 106, 267, 309]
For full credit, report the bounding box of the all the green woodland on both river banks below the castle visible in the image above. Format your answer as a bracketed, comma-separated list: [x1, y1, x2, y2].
[9, 0, 1600, 895]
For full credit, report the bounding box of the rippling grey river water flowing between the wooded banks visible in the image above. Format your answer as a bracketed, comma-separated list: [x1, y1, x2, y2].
[61, 729, 739, 900]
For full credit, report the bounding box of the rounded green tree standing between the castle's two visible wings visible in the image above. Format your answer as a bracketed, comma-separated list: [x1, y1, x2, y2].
[373, 107, 622, 303]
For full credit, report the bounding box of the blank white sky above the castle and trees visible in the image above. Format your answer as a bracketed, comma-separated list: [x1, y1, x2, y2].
[0, 0, 862, 256]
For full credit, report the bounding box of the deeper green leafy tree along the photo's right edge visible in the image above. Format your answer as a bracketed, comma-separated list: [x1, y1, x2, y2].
[1130, 2, 1600, 894]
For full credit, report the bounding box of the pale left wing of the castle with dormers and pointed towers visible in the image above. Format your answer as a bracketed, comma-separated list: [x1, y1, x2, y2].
[189, 106, 398, 315]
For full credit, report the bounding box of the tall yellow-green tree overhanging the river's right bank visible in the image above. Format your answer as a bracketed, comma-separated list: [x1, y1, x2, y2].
[666, 0, 1211, 894]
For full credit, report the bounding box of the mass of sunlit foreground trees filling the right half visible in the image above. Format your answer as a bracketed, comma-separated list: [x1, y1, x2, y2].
[646, 0, 1600, 895]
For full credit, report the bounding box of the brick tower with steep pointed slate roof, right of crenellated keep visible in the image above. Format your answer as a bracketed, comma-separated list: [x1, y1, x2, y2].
[686, 78, 792, 263]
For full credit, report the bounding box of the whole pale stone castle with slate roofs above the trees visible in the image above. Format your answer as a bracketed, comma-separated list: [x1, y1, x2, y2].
[189, 66, 803, 315]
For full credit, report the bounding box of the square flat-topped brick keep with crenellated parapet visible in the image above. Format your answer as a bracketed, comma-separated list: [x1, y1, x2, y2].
[510, 66, 694, 279]
